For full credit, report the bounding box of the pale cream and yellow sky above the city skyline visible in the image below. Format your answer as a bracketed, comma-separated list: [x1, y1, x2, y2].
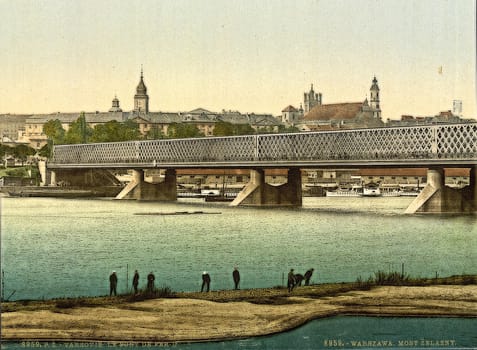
[0, 0, 477, 119]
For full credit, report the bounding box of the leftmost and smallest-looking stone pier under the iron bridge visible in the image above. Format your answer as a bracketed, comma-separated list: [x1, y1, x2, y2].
[116, 169, 177, 201]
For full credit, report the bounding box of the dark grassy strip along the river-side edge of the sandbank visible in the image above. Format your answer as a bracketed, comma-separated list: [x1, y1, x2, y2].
[1, 271, 477, 312]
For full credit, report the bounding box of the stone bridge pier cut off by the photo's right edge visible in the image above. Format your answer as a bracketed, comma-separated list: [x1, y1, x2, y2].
[405, 166, 477, 214]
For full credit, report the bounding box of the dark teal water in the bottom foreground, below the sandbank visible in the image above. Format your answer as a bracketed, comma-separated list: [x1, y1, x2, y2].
[3, 317, 477, 350]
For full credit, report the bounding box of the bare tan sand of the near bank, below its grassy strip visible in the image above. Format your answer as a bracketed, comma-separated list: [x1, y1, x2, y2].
[1, 285, 477, 342]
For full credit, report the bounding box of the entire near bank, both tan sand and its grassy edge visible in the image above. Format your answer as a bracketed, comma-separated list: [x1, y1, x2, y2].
[1, 271, 477, 343]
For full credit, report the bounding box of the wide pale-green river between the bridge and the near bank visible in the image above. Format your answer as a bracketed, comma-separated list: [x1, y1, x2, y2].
[0, 197, 477, 347]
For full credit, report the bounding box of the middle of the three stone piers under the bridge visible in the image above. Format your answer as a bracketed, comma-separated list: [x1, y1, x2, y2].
[230, 168, 302, 207]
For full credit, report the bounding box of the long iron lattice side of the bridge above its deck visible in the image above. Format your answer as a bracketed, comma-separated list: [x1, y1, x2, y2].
[51, 123, 477, 165]
